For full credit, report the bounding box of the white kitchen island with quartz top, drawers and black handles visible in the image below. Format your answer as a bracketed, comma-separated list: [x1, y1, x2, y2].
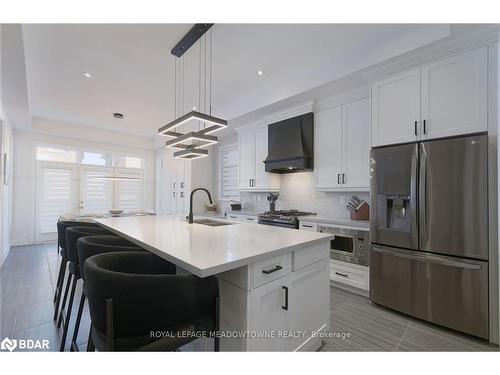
[95, 216, 332, 351]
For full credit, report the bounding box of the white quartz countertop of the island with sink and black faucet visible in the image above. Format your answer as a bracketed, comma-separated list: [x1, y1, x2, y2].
[95, 216, 332, 277]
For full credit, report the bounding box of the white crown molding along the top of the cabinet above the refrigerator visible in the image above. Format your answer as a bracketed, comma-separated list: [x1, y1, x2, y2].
[359, 25, 499, 82]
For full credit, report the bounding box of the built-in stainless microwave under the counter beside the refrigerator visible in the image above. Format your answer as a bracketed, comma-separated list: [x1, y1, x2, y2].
[318, 225, 370, 266]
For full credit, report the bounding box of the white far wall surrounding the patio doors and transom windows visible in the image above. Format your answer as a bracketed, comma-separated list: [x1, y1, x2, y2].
[11, 119, 155, 245]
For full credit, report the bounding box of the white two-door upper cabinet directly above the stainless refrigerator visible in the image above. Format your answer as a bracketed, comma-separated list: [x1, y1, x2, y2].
[372, 46, 488, 146]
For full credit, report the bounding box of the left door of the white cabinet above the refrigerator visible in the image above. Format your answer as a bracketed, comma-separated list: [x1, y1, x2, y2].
[372, 69, 420, 146]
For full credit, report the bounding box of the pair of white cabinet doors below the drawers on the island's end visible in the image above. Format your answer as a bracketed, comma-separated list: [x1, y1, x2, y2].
[249, 259, 330, 351]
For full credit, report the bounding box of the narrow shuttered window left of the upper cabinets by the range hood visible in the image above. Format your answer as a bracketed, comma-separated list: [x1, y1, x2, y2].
[219, 145, 240, 200]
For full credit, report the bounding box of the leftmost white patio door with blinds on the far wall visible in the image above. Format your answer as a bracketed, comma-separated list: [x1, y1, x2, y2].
[35, 162, 78, 241]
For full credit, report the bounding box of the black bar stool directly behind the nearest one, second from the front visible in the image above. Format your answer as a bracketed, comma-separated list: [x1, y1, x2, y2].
[71, 235, 146, 351]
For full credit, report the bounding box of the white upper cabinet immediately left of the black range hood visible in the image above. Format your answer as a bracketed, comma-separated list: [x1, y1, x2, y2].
[238, 126, 280, 191]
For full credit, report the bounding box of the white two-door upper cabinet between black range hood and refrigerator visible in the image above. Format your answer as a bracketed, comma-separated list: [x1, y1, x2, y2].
[314, 98, 370, 191]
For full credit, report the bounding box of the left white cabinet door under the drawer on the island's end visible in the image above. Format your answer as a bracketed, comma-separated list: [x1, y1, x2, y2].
[249, 276, 289, 352]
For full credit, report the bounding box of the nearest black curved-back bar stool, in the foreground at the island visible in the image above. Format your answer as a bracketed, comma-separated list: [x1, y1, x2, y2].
[84, 252, 219, 351]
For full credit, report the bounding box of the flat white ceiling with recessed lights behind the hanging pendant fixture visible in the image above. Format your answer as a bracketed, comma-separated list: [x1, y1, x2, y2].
[23, 24, 449, 136]
